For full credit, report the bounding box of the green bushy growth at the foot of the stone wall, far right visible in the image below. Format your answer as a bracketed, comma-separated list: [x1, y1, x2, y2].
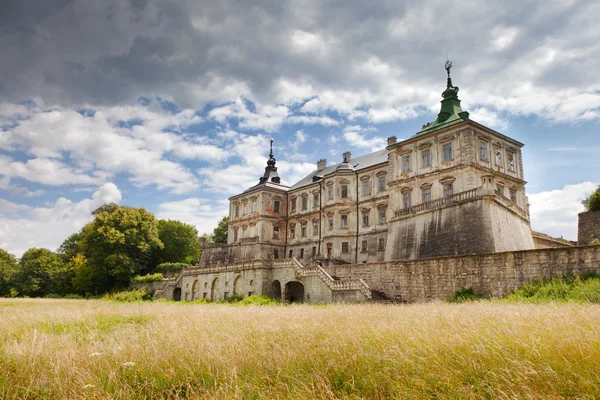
[505, 273, 600, 303]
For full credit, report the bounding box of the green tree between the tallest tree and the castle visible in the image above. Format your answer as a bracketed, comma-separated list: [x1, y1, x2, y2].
[153, 219, 200, 267]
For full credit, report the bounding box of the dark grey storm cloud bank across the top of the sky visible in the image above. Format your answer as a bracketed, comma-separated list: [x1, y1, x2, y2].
[0, 0, 600, 115]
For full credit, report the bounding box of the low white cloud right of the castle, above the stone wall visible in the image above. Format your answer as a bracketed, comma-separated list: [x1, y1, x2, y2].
[529, 182, 597, 240]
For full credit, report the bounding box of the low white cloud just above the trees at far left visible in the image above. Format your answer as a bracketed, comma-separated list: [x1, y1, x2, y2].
[0, 183, 122, 257]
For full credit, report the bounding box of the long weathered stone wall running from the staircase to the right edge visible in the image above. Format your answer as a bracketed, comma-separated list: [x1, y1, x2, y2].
[324, 246, 600, 302]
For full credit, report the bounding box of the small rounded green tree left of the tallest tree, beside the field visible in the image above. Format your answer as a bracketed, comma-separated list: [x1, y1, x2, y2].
[13, 248, 72, 297]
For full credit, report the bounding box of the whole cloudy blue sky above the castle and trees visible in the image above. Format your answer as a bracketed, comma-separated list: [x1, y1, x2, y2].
[0, 0, 600, 256]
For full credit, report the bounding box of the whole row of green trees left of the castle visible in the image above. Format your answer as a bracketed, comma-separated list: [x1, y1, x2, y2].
[0, 203, 228, 297]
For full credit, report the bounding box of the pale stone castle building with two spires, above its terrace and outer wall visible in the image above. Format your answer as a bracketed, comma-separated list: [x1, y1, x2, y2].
[202, 69, 534, 265]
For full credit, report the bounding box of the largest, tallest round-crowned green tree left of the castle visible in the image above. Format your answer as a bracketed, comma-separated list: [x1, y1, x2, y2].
[76, 203, 163, 294]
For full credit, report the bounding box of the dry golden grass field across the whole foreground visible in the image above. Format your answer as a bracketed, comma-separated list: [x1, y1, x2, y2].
[0, 299, 600, 399]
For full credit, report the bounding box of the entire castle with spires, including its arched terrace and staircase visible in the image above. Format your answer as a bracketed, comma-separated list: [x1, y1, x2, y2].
[157, 64, 598, 302]
